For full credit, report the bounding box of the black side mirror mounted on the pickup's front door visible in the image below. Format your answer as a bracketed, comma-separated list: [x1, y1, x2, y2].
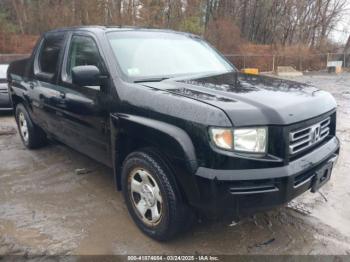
[72, 65, 102, 86]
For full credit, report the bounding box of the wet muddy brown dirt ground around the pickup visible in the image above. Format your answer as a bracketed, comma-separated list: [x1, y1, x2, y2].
[0, 73, 350, 255]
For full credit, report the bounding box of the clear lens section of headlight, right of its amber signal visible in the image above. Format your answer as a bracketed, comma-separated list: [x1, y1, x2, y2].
[233, 127, 267, 153]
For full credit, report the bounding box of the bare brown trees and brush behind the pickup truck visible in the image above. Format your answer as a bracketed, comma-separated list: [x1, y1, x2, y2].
[0, 0, 347, 54]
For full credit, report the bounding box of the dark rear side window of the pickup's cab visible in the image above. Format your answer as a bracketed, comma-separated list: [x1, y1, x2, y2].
[38, 33, 65, 75]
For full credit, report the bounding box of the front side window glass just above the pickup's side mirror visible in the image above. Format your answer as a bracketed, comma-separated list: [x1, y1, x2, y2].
[66, 35, 103, 79]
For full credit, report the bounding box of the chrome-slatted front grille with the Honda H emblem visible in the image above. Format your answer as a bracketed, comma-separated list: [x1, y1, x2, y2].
[289, 117, 331, 155]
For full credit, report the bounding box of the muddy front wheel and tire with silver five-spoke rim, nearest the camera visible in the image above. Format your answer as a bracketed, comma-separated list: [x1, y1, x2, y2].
[122, 149, 194, 241]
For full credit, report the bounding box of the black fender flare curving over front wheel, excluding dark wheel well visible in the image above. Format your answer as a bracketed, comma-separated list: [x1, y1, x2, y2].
[110, 114, 199, 202]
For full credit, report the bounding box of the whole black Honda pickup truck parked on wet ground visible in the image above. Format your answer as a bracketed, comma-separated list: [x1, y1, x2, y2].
[7, 26, 339, 240]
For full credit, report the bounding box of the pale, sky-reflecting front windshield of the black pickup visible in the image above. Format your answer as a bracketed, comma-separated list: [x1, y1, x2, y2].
[108, 31, 234, 80]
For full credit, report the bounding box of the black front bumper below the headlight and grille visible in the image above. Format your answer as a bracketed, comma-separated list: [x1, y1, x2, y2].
[196, 137, 339, 217]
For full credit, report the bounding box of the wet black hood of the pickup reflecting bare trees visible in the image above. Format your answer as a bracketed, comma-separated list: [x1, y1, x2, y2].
[144, 72, 336, 126]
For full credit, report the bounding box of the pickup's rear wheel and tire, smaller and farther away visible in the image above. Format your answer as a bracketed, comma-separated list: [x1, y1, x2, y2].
[15, 104, 47, 149]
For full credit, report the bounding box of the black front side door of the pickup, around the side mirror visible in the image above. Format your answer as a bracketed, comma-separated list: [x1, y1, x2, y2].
[56, 32, 111, 165]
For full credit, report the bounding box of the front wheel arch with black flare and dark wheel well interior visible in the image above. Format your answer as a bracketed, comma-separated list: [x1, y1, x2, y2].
[110, 114, 199, 206]
